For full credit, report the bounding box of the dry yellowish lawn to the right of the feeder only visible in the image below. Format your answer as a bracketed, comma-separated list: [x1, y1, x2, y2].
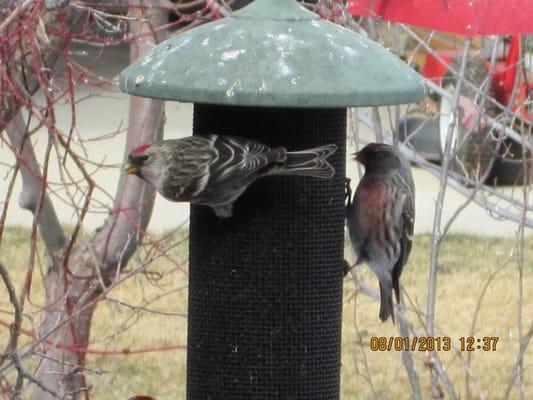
[342, 235, 533, 399]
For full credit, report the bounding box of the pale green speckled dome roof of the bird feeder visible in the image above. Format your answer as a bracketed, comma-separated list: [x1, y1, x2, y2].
[120, 0, 425, 108]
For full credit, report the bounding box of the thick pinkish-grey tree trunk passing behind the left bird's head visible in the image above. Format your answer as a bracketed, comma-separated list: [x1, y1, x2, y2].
[31, 1, 167, 400]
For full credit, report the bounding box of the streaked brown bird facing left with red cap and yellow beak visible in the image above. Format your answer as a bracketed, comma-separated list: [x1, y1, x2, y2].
[124, 134, 337, 218]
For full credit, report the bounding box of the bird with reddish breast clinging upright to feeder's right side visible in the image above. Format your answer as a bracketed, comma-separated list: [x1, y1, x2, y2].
[346, 143, 415, 323]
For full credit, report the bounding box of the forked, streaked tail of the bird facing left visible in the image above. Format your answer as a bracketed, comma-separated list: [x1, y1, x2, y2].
[273, 144, 337, 179]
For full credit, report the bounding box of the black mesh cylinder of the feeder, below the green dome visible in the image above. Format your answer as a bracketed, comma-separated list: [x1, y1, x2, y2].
[187, 105, 346, 400]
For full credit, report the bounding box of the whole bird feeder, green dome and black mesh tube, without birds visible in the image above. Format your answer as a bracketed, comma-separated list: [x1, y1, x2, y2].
[120, 0, 424, 400]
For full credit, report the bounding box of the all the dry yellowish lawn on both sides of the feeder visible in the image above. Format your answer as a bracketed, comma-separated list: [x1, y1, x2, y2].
[0, 229, 533, 400]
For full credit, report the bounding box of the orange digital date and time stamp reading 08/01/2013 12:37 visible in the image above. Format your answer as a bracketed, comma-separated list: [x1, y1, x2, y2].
[370, 336, 499, 351]
